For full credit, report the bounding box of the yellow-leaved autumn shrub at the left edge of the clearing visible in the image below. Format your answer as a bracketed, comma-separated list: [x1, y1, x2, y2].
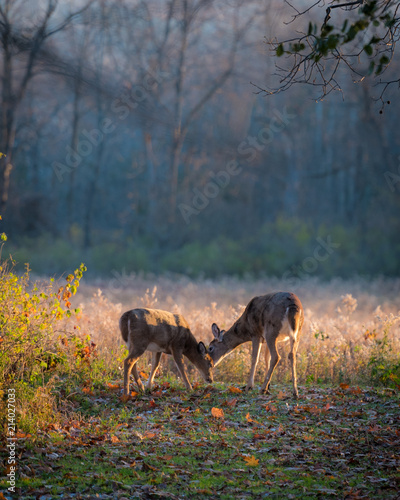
[0, 260, 93, 431]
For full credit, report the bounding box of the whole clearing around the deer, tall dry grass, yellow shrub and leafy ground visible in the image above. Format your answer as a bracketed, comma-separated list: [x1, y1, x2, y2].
[0, 268, 400, 500]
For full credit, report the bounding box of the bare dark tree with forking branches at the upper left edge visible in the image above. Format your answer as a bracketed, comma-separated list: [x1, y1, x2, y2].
[0, 0, 93, 213]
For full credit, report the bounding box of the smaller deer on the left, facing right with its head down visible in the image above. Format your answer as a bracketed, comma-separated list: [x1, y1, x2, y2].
[119, 309, 214, 395]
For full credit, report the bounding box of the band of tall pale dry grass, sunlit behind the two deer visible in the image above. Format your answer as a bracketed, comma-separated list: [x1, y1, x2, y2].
[70, 275, 400, 384]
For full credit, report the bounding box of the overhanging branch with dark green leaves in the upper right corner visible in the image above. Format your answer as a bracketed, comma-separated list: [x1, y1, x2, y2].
[257, 0, 400, 102]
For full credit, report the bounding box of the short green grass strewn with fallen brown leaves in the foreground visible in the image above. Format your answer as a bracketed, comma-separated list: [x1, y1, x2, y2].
[0, 378, 400, 500]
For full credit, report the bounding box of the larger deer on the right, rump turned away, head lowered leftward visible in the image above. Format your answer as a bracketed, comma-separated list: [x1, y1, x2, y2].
[209, 292, 304, 398]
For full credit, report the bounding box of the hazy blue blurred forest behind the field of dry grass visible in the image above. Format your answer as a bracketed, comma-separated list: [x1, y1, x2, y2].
[0, 0, 400, 278]
